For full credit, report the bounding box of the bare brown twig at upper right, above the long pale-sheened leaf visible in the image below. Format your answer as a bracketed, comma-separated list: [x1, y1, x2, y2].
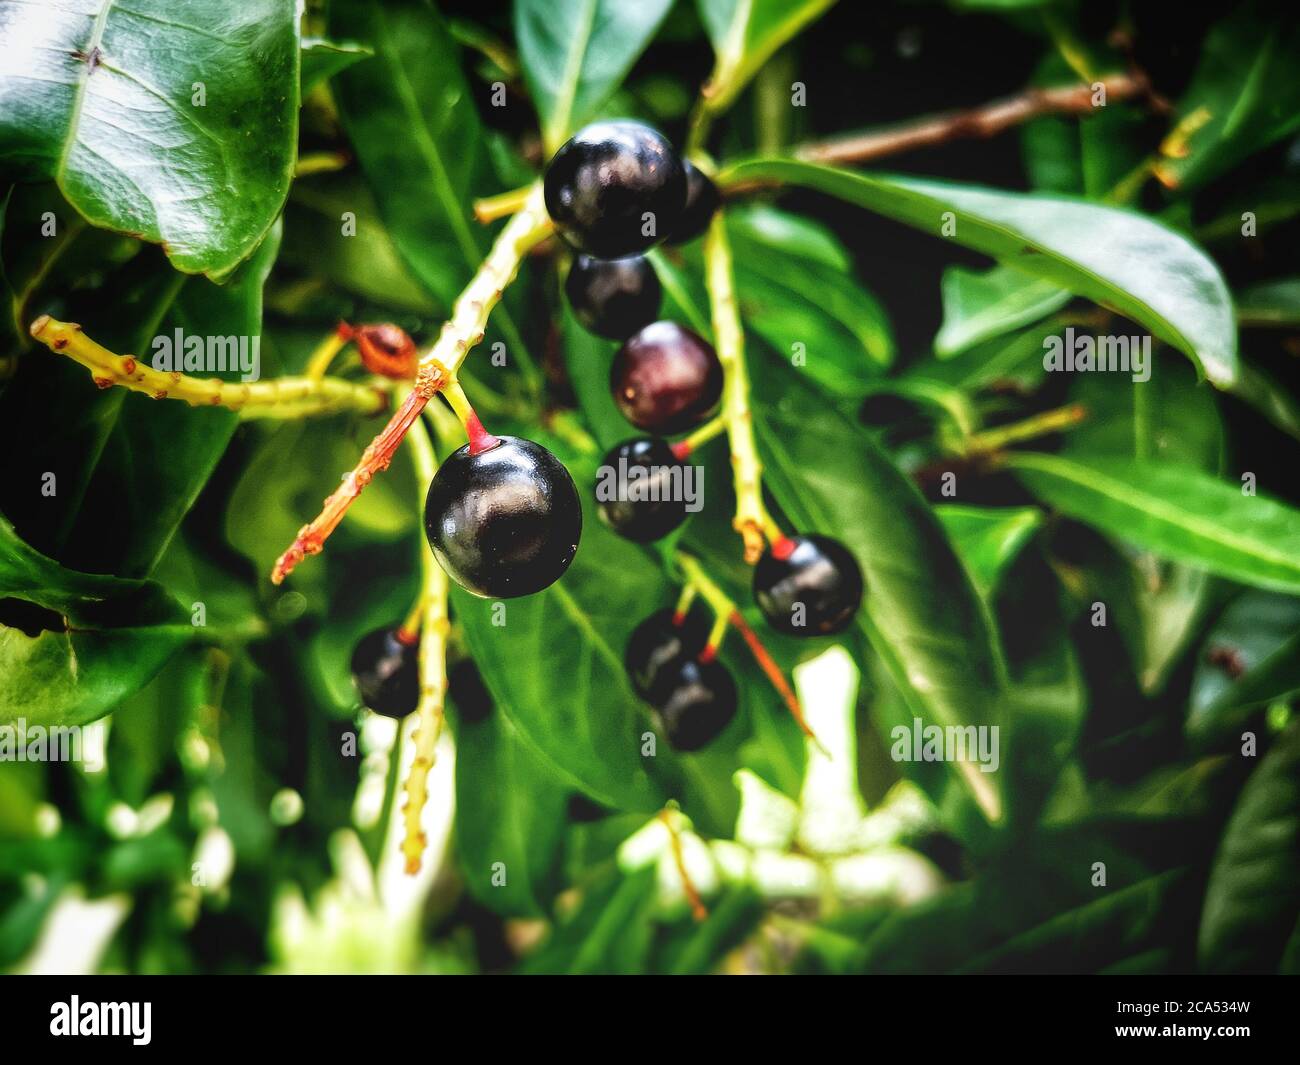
[794, 73, 1151, 164]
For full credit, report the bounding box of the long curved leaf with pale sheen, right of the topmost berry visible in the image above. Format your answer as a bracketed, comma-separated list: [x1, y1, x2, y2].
[720, 159, 1238, 389]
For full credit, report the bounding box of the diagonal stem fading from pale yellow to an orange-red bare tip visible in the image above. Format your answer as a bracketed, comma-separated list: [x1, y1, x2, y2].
[270, 182, 553, 584]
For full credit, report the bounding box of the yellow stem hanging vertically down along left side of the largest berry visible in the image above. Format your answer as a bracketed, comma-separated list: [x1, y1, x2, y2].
[402, 417, 449, 875]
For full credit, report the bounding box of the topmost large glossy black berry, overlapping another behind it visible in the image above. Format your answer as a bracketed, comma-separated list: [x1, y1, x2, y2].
[543, 122, 686, 259]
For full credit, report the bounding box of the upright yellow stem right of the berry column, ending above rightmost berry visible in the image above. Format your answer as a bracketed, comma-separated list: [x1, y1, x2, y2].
[705, 211, 771, 566]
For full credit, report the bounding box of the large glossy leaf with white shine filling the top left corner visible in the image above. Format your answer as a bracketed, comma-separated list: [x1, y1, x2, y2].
[0, 0, 299, 278]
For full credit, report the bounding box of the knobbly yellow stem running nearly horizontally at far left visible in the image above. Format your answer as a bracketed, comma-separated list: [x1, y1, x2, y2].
[31, 315, 389, 419]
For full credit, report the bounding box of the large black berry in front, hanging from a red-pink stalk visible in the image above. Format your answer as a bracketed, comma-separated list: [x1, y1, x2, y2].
[424, 437, 582, 599]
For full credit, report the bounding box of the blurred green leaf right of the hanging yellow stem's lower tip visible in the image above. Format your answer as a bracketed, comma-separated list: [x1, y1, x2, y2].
[456, 711, 568, 917]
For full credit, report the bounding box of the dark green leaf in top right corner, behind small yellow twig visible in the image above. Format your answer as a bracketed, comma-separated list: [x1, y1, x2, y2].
[1158, 3, 1300, 189]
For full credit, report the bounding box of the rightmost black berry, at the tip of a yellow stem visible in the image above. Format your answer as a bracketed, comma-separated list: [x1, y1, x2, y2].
[754, 536, 863, 636]
